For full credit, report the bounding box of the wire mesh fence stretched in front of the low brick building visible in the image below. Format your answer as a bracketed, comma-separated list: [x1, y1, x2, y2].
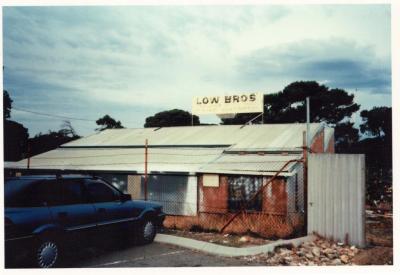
[8, 148, 305, 238]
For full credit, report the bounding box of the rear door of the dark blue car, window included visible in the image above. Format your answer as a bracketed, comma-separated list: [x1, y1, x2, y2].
[49, 179, 96, 242]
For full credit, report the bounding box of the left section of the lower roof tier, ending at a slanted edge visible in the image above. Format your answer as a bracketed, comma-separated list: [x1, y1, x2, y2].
[9, 148, 223, 173]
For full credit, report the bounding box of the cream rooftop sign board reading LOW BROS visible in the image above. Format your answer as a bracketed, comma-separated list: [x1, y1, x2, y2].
[192, 93, 264, 115]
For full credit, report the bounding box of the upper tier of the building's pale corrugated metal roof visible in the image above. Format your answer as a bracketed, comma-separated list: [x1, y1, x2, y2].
[63, 123, 323, 150]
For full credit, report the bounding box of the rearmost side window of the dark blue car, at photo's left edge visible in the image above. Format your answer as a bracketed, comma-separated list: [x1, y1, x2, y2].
[4, 179, 37, 207]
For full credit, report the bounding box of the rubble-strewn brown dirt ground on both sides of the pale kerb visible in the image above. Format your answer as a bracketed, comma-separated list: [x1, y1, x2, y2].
[162, 211, 393, 265]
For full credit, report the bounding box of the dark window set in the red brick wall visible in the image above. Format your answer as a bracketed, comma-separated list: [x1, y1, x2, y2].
[228, 177, 262, 211]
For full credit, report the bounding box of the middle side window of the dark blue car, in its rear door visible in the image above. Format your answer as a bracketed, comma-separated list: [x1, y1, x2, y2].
[61, 179, 87, 205]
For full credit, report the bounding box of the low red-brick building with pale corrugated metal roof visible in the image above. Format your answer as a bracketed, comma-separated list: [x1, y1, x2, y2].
[6, 123, 334, 236]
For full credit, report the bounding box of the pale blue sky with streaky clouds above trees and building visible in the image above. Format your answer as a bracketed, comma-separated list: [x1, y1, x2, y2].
[3, 4, 392, 136]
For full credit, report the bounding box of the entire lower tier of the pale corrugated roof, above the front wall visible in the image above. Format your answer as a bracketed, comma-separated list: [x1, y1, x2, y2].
[8, 148, 301, 174]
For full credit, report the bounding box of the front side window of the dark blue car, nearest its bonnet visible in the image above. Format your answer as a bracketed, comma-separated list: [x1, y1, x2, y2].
[85, 179, 120, 202]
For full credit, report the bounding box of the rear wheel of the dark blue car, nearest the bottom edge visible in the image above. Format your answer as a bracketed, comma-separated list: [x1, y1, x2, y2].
[34, 238, 60, 268]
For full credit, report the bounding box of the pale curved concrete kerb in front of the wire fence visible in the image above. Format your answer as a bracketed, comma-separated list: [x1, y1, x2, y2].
[155, 234, 317, 257]
